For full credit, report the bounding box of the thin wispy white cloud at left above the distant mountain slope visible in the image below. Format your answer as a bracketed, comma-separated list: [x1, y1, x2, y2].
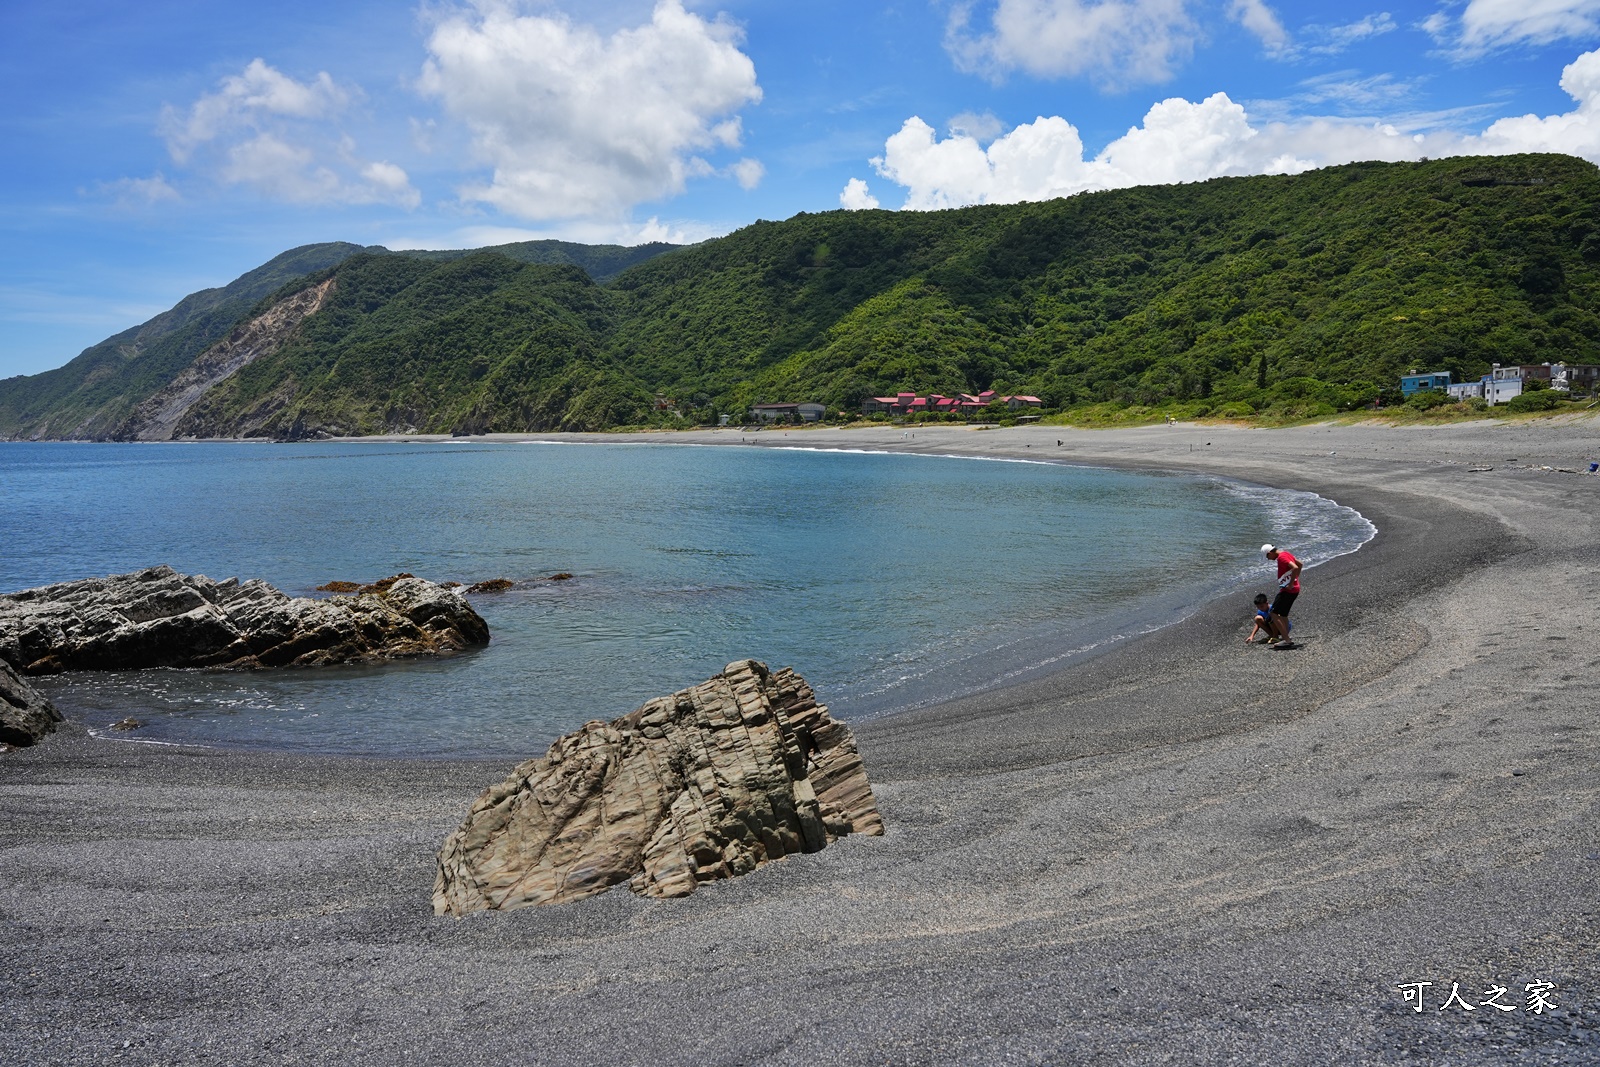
[160, 59, 421, 208]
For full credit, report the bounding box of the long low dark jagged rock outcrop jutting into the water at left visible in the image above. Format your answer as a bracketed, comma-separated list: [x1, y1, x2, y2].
[0, 566, 490, 673]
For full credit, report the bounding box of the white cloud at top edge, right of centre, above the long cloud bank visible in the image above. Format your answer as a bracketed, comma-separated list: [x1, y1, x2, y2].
[944, 0, 1203, 86]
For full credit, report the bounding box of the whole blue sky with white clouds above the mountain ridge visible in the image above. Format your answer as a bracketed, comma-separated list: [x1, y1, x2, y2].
[0, 0, 1600, 378]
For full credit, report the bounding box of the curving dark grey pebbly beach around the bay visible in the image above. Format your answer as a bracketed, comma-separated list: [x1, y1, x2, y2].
[0, 418, 1600, 1065]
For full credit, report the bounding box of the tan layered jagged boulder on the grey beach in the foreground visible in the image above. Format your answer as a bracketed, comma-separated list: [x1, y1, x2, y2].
[434, 659, 883, 915]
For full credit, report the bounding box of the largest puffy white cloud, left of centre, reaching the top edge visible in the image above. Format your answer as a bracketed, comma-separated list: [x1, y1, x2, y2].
[421, 0, 763, 219]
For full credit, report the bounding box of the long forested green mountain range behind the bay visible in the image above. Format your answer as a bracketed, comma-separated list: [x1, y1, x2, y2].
[0, 155, 1600, 437]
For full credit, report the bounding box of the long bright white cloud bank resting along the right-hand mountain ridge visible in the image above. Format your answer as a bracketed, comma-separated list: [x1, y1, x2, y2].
[840, 51, 1600, 210]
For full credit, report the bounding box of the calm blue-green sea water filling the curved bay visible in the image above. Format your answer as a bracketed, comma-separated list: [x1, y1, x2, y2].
[0, 442, 1371, 758]
